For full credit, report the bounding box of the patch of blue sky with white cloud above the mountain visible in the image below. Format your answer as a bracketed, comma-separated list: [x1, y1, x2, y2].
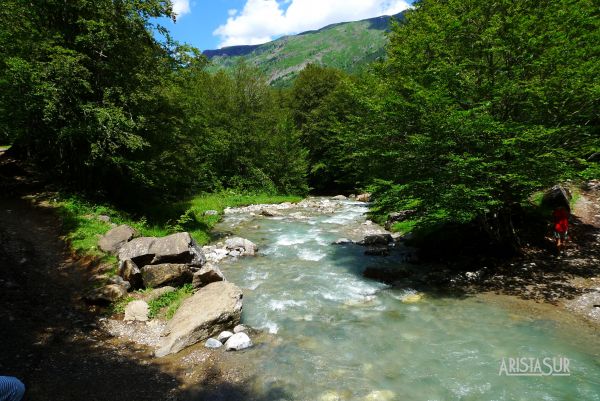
[162, 0, 412, 50]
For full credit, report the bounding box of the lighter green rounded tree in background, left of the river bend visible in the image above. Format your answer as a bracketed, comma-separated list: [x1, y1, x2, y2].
[172, 59, 307, 193]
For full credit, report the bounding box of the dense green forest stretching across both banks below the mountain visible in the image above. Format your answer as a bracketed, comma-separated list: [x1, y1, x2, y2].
[0, 0, 600, 248]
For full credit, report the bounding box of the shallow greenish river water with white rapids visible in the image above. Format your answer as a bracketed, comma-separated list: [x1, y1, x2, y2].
[212, 199, 600, 401]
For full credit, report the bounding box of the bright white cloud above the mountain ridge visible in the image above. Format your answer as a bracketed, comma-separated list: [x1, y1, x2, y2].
[213, 0, 410, 47]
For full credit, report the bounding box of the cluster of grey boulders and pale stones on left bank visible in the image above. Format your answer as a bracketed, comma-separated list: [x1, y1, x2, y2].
[87, 225, 257, 357]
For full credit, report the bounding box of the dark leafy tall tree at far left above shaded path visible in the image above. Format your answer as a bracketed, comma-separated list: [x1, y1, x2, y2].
[0, 0, 202, 200]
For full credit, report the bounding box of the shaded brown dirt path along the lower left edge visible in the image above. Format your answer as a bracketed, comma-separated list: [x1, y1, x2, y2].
[0, 200, 188, 401]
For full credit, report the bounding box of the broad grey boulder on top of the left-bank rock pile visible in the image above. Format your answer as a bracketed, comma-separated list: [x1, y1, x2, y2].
[119, 232, 206, 266]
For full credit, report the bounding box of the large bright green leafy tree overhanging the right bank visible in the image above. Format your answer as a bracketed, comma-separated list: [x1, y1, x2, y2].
[361, 0, 600, 242]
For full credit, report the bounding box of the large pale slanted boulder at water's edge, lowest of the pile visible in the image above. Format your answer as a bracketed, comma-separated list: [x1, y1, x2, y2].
[155, 281, 242, 357]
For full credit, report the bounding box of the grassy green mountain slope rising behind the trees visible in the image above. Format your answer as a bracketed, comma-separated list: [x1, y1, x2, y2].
[204, 14, 402, 86]
